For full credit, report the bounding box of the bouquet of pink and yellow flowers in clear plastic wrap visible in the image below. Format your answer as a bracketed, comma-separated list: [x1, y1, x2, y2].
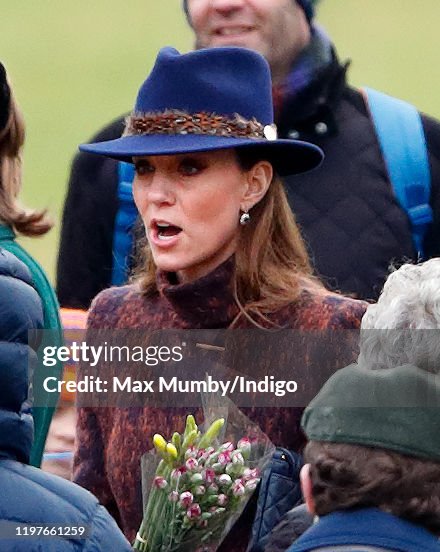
[133, 396, 275, 552]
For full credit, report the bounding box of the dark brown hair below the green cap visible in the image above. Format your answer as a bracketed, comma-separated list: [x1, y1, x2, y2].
[304, 441, 440, 536]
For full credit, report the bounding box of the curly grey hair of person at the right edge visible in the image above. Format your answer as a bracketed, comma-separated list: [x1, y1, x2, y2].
[359, 258, 440, 373]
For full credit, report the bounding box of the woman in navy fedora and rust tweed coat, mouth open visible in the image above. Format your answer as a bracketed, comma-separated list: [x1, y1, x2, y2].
[74, 48, 366, 551]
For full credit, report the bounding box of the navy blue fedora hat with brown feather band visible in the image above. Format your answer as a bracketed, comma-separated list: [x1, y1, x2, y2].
[80, 47, 323, 175]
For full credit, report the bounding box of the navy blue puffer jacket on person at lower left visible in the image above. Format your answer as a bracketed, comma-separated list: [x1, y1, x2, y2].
[0, 248, 131, 552]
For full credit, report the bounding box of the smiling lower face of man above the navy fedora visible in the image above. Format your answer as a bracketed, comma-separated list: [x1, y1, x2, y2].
[188, 0, 310, 82]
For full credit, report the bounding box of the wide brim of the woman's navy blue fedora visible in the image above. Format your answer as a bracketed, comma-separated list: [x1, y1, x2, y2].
[79, 134, 324, 176]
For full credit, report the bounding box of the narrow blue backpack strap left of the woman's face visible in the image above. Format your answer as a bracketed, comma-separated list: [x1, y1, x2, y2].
[111, 161, 138, 286]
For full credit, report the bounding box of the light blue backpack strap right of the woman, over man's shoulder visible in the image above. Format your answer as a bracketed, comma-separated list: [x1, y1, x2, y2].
[364, 88, 433, 259]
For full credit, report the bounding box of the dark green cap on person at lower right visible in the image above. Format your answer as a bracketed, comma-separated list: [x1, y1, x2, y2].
[301, 365, 440, 461]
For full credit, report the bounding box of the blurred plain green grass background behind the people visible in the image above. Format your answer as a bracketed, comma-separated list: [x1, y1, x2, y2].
[0, 0, 440, 281]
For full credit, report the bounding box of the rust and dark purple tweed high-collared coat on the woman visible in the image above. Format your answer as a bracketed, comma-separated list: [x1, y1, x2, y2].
[74, 259, 366, 552]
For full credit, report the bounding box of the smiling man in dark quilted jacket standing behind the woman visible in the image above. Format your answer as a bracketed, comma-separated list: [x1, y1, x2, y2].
[57, 0, 440, 308]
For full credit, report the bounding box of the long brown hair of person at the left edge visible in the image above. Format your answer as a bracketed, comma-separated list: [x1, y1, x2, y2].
[0, 91, 53, 237]
